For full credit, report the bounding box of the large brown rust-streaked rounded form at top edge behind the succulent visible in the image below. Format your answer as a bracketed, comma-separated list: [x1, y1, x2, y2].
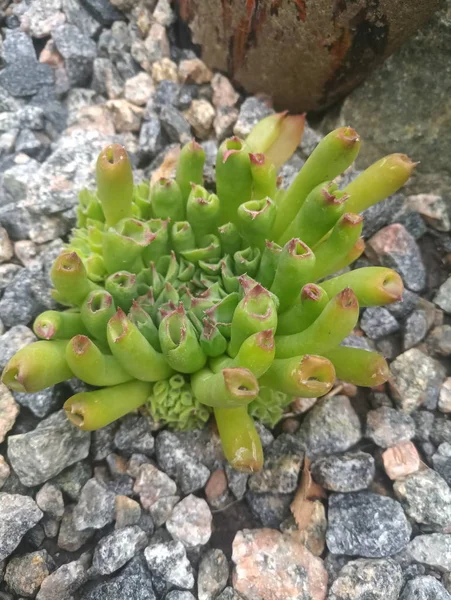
[176, 0, 440, 111]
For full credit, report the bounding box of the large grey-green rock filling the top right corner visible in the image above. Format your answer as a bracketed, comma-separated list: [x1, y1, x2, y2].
[330, 0, 451, 191]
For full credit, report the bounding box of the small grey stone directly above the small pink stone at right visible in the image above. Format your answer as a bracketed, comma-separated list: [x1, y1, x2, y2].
[365, 406, 415, 448]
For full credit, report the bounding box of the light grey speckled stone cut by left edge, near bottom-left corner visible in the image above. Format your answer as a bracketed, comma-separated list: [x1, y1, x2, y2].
[0, 492, 43, 560]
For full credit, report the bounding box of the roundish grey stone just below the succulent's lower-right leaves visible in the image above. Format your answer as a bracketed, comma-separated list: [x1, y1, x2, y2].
[298, 396, 362, 459]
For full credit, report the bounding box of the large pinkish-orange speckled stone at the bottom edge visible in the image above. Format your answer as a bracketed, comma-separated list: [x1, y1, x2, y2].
[232, 529, 327, 600]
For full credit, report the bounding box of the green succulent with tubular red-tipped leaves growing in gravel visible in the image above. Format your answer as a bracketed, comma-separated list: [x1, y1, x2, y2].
[2, 113, 414, 471]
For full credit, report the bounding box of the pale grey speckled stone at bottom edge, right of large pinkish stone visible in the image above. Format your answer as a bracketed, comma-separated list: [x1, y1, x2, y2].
[327, 559, 404, 600]
